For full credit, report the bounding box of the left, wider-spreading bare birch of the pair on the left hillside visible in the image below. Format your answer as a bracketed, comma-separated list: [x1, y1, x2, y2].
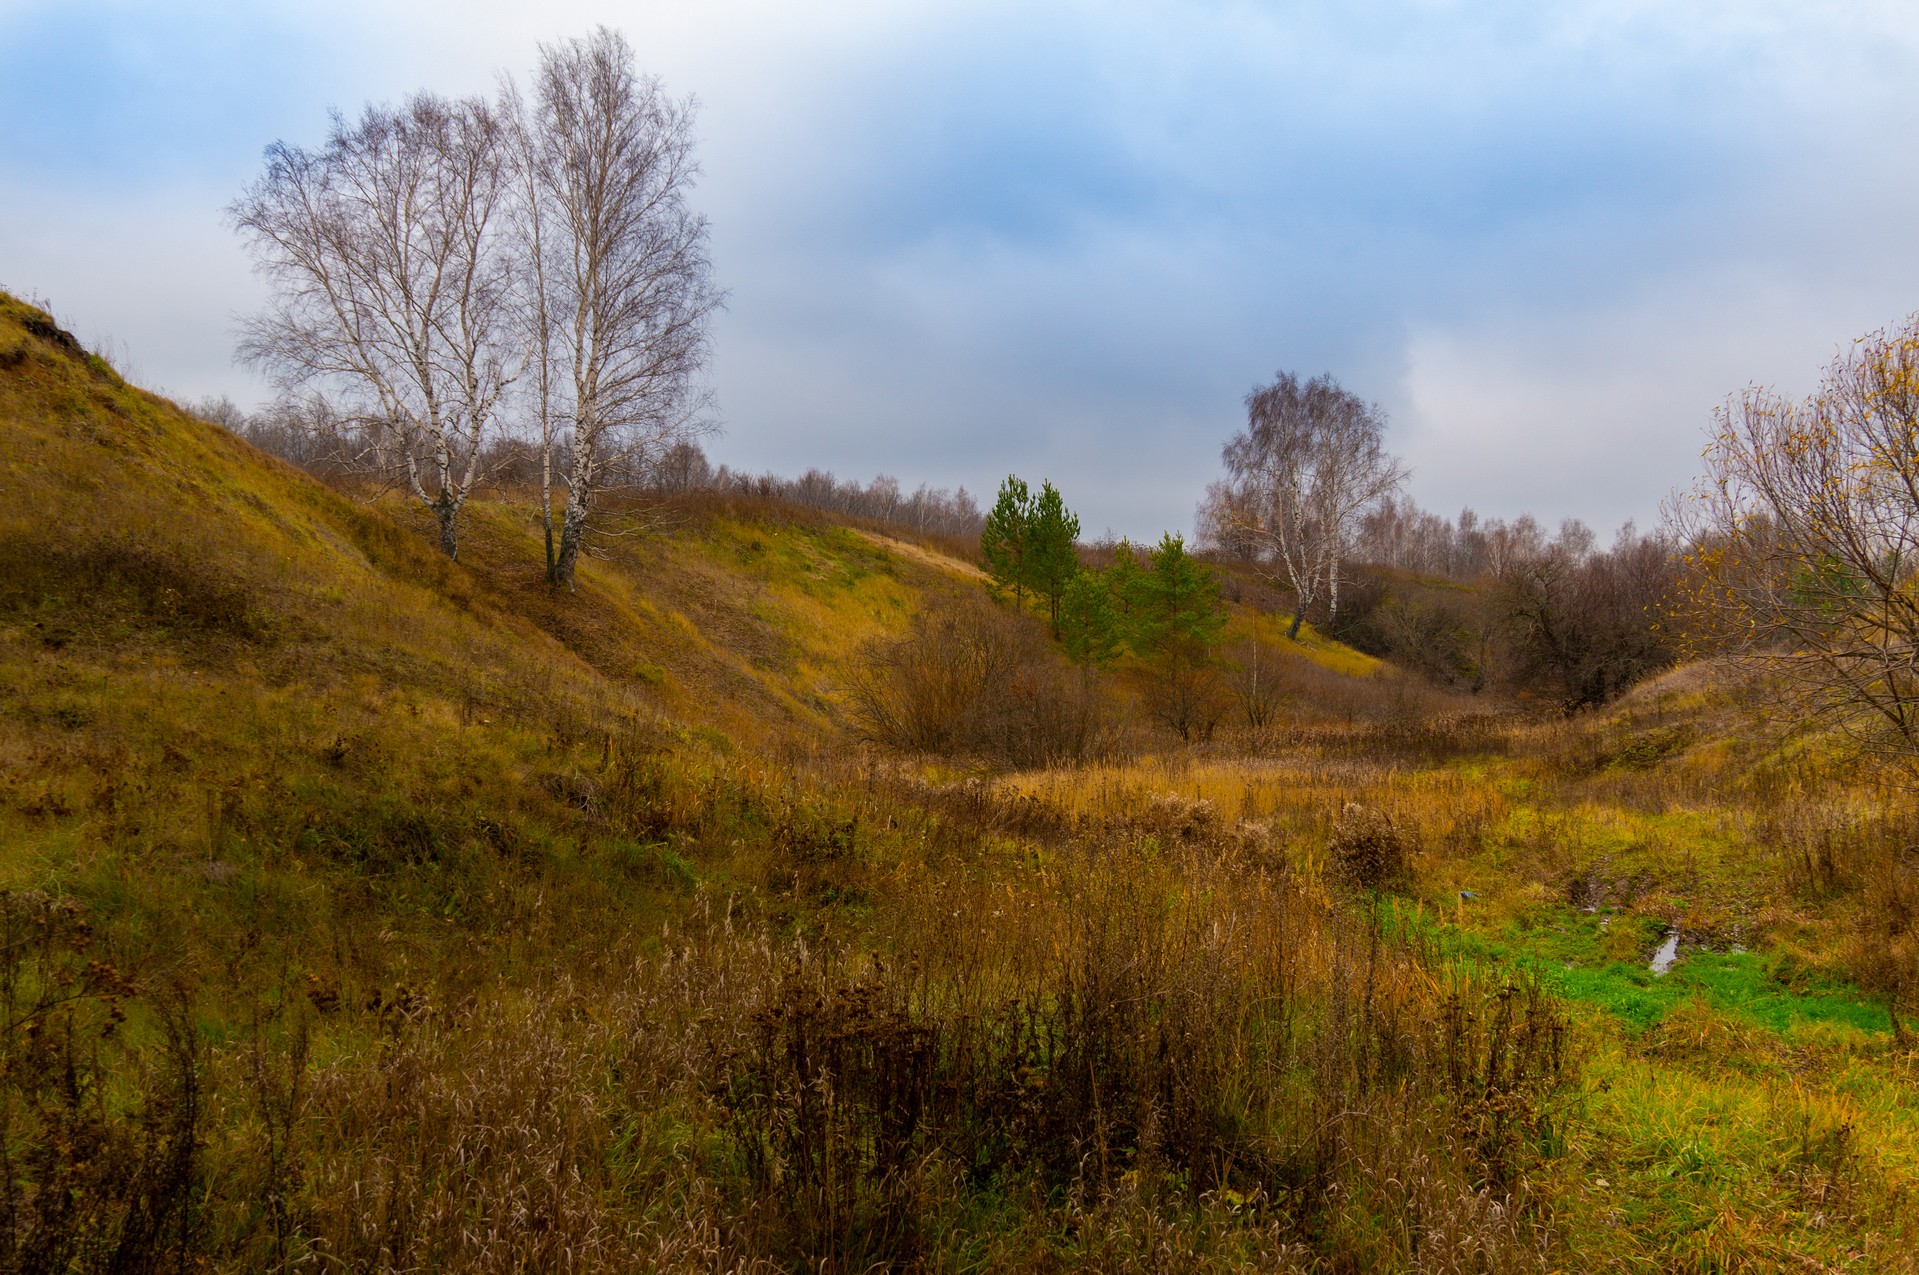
[228, 94, 516, 557]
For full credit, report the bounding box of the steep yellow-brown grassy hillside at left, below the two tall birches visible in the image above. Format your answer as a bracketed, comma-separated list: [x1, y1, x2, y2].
[0, 286, 990, 995]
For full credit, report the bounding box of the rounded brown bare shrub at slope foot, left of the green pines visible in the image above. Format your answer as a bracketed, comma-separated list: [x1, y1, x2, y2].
[852, 597, 1105, 766]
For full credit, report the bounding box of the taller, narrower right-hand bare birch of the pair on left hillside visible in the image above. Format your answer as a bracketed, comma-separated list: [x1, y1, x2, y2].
[503, 27, 722, 584]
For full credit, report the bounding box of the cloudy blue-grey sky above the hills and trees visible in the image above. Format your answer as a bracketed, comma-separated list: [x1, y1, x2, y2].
[0, 0, 1919, 540]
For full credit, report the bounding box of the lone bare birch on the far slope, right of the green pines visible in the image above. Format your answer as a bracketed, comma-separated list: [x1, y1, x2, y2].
[1199, 373, 1407, 639]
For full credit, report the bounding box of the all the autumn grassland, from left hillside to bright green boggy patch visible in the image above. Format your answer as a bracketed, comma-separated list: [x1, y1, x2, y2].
[0, 298, 1919, 1271]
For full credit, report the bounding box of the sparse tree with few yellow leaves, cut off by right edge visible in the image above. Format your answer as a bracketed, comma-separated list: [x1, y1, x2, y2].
[1671, 315, 1919, 772]
